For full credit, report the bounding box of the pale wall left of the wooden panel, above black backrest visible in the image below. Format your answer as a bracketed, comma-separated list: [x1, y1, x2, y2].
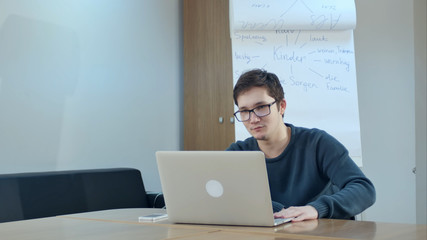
[0, 0, 183, 190]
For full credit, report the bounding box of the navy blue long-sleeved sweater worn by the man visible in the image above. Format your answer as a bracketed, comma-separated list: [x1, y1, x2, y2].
[227, 124, 375, 219]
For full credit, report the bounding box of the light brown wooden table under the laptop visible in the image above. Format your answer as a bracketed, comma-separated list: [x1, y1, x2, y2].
[0, 209, 427, 240]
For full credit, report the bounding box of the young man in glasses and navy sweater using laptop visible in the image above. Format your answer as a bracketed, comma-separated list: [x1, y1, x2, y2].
[227, 69, 375, 221]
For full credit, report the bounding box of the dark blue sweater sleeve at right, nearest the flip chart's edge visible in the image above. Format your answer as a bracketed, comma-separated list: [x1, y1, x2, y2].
[308, 134, 376, 219]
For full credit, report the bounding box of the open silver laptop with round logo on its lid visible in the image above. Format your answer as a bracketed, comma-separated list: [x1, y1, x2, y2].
[156, 151, 291, 226]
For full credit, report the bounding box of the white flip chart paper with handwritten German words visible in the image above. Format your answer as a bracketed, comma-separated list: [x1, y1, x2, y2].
[230, 0, 362, 166]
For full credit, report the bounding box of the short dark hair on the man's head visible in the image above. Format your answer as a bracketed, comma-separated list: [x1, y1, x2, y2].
[233, 69, 285, 106]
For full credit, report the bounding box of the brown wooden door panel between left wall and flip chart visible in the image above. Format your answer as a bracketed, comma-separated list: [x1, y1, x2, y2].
[183, 0, 234, 150]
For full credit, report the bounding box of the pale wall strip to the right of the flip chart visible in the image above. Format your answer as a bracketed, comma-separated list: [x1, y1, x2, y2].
[354, 0, 425, 223]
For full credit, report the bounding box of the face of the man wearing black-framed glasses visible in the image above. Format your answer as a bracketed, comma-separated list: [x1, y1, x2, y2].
[237, 87, 286, 140]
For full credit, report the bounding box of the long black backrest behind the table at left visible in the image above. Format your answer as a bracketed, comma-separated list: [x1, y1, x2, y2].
[0, 168, 149, 222]
